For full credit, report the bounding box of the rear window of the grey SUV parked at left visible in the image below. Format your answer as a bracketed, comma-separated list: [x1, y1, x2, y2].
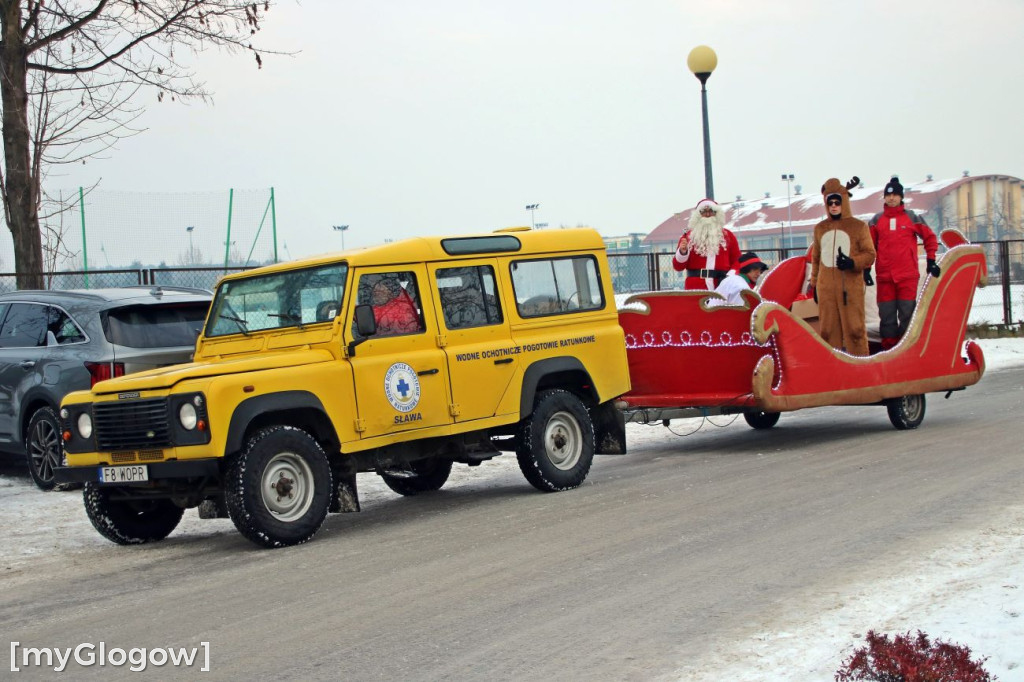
[102, 301, 210, 348]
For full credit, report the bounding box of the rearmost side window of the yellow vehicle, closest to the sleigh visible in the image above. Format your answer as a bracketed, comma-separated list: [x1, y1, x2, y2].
[511, 256, 604, 317]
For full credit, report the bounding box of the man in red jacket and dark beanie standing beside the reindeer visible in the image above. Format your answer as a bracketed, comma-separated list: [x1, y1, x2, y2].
[869, 176, 941, 350]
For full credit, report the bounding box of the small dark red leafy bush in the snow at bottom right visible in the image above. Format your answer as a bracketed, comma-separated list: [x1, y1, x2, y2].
[836, 630, 995, 682]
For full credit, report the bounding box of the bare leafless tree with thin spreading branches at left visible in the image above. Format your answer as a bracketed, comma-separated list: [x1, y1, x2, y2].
[0, 0, 270, 289]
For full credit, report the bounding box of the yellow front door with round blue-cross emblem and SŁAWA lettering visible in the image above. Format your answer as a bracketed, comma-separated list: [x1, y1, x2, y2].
[348, 265, 452, 438]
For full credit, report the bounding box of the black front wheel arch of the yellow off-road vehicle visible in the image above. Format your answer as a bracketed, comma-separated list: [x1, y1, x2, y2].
[224, 391, 341, 455]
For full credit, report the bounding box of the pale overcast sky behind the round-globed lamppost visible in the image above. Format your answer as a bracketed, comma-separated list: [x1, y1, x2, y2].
[49, 0, 1024, 257]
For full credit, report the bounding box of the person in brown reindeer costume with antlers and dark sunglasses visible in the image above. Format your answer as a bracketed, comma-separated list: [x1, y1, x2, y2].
[810, 176, 874, 355]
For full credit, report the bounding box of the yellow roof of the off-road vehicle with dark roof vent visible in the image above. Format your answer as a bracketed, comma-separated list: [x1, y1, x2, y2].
[214, 227, 605, 281]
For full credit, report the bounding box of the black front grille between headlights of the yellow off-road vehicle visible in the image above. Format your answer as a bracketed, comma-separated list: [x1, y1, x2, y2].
[92, 398, 171, 451]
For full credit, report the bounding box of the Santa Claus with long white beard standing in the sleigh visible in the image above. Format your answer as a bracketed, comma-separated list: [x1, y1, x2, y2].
[672, 199, 739, 290]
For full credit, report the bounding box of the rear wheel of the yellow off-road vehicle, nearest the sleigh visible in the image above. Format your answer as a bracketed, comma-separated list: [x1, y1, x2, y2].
[515, 389, 594, 493]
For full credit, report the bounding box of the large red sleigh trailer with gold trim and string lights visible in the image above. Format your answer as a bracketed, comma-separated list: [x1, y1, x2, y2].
[618, 230, 987, 429]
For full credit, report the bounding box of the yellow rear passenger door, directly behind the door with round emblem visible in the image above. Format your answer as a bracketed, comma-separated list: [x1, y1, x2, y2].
[430, 258, 521, 422]
